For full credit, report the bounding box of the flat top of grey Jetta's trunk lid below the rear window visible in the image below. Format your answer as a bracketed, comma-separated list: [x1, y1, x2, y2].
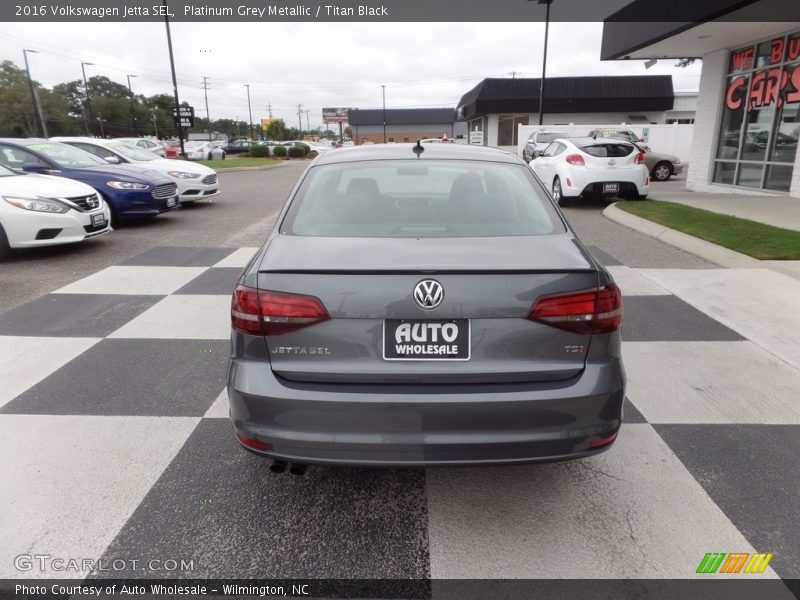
[259, 233, 594, 272]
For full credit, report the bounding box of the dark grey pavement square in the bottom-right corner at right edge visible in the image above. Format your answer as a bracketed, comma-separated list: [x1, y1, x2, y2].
[654, 424, 800, 579]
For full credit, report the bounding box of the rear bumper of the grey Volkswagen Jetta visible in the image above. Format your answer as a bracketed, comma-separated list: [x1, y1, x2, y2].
[228, 358, 625, 466]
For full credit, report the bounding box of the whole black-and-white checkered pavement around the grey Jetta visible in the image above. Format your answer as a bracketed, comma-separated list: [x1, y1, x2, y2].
[0, 247, 800, 578]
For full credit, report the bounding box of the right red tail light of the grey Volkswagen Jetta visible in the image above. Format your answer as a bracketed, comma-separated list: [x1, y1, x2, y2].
[528, 283, 622, 334]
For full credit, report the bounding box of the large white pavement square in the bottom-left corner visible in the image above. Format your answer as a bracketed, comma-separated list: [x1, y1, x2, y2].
[0, 415, 199, 578]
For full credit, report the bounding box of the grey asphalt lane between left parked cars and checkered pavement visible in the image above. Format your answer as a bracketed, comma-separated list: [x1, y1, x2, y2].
[0, 161, 308, 313]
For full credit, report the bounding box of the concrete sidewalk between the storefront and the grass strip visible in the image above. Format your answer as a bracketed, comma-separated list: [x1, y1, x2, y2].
[649, 177, 800, 231]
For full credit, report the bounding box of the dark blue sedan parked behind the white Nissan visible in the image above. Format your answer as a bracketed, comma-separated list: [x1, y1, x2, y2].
[0, 138, 179, 225]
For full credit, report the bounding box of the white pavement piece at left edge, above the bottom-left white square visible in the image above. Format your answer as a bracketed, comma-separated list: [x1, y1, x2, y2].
[0, 335, 100, 407]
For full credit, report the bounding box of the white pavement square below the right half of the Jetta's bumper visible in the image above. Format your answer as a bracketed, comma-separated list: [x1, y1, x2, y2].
[426, 424, 776, 579]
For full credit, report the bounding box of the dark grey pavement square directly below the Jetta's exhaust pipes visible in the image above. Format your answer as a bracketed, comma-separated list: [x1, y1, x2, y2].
[95, 419, 430, 579]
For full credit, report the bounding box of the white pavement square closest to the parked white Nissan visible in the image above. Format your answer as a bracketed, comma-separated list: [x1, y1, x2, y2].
[55, 266, 207, 296]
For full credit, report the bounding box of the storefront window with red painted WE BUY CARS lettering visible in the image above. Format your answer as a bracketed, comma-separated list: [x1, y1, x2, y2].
[712, 32, 800, 191]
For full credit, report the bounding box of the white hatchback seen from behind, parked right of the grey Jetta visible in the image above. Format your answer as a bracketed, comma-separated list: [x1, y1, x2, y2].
[529, 138, 650, 206]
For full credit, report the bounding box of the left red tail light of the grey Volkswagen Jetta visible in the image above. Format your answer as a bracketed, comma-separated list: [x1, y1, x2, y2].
[231, 285, 330, 335]
